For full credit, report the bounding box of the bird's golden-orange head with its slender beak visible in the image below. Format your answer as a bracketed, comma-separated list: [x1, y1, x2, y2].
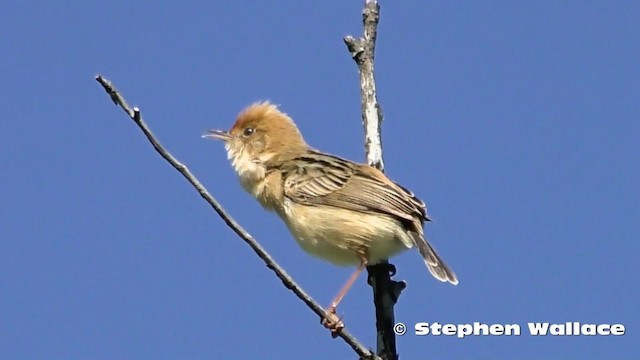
[204, 101, 307, 167]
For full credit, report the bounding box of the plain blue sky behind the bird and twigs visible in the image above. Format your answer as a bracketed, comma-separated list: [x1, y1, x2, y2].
[0, 0, 640, 359]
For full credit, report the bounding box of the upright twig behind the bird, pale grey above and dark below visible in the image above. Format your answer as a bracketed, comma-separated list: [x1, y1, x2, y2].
[344, 0, 406, 360]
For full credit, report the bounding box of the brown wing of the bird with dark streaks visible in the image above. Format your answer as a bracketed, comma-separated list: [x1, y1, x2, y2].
[282, 152, 429, 222]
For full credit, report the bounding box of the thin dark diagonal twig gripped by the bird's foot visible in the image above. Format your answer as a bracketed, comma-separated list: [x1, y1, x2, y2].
[96, 75, 380, 360]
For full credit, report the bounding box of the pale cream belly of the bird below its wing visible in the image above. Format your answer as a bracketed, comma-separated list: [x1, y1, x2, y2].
[280, 200, 412, 265]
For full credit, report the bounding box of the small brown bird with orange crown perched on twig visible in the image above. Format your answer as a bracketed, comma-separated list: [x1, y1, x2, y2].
[203, 102, 458, 331]
